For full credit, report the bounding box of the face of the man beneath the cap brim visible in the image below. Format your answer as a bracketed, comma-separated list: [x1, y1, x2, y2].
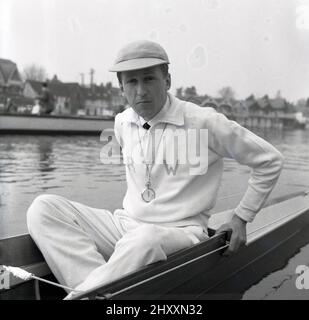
[120, 66, 171, 121]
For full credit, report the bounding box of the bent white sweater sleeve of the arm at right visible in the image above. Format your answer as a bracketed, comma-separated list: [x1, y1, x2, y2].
[209, 113, 283, 222]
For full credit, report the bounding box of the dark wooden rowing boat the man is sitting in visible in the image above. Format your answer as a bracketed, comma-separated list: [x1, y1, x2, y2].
[0, 192, 309, 300]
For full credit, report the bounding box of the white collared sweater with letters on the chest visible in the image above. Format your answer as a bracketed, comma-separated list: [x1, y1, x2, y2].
[115, 94, 283, 228]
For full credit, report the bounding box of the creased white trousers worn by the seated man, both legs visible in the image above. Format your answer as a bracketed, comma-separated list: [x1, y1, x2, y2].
[27, 195, 207, 290]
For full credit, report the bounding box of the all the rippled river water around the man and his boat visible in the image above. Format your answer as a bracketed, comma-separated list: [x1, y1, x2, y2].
[0, 129, 309, 299]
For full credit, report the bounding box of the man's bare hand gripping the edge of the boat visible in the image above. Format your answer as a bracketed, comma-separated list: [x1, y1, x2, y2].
[216, 214, 247, 256]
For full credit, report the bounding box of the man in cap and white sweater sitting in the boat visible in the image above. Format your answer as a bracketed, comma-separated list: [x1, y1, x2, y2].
[27, 41, 283, 298]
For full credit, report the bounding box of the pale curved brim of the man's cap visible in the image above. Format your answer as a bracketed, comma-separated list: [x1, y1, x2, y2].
[109, 58, 169, 72]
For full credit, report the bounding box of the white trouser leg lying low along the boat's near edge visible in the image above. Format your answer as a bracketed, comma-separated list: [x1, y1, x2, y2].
[76, 224, 206, 290]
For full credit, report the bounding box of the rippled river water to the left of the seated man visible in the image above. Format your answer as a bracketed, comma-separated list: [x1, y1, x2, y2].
[0, 135, 125, 237]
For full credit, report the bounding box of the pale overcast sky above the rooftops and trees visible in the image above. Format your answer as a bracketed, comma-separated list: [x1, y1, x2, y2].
[0, 0, 309, 101]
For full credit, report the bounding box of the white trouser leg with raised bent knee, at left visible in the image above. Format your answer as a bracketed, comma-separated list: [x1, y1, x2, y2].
[27, 195, 121, 288]
